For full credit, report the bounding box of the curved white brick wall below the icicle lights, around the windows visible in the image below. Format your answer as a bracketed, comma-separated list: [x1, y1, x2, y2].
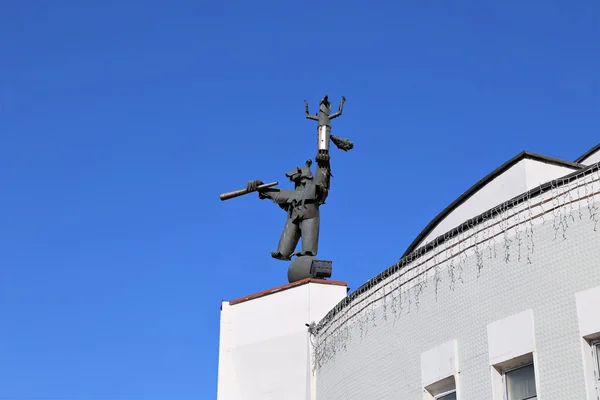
[317, 212, 600, 400]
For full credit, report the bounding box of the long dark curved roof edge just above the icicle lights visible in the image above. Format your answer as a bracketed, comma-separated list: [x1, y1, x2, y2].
[317, 160, 600, 331]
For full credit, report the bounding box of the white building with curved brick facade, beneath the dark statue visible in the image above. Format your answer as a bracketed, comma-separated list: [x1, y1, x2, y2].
[218, 146, 600, 400]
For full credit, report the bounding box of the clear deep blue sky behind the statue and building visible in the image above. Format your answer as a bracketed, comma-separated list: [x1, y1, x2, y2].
[0, 0, 600, 400]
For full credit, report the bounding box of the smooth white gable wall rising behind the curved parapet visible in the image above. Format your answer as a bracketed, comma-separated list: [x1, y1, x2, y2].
[417, 158, 574, 247]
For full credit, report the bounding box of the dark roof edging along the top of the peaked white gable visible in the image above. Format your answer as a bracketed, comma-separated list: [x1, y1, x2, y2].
[402, 152, 584, 257]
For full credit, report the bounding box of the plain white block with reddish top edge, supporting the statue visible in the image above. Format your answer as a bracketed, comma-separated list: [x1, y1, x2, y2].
[217, 282, 347, 400]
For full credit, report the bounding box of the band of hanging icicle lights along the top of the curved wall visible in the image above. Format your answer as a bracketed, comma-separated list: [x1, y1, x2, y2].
[311, 163, 600, 368]
